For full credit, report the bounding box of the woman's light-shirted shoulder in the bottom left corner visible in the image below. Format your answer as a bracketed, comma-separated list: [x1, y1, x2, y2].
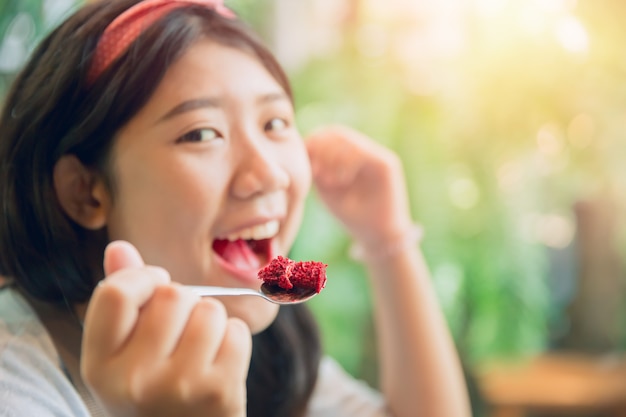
[0, 287, 88, 417]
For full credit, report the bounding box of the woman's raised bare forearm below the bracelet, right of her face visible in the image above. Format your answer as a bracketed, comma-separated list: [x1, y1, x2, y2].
[367, 247, 470, 417]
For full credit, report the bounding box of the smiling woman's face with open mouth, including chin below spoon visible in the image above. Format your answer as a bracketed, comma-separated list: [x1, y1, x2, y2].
[107, 40, 311, 332]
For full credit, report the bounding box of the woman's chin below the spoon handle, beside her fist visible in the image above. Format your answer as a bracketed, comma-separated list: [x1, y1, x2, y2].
[220, 297, 279, 334]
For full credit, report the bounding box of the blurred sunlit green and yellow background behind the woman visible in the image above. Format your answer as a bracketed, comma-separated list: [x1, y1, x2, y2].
[0, 0, 626, 416]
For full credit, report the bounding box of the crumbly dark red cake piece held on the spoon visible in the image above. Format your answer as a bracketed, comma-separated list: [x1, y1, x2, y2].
[258, 256, 328, 293]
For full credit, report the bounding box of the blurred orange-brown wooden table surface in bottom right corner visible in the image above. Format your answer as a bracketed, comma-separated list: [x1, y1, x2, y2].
[476, 353, 626, 417]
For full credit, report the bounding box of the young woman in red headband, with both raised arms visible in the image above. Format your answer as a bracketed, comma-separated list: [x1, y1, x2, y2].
[0, 0, 469, 417]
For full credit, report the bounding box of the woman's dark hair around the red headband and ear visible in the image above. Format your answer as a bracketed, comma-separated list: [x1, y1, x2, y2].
[0, 0, 320, 416]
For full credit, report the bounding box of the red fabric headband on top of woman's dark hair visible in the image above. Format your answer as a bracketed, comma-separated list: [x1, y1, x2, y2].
[87, 0, 235, 84]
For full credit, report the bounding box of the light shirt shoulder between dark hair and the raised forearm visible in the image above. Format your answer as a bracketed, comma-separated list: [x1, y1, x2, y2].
[306, 356, 391, 417]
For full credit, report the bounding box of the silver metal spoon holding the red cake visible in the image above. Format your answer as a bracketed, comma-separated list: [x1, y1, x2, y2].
[183, 284, 317, 305]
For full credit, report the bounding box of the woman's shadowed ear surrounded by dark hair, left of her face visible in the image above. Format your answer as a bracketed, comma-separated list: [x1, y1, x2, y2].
[54, 155, 109, 230]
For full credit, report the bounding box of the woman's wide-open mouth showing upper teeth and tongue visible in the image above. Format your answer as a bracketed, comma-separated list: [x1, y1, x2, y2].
[213, 239, 271, 271]
